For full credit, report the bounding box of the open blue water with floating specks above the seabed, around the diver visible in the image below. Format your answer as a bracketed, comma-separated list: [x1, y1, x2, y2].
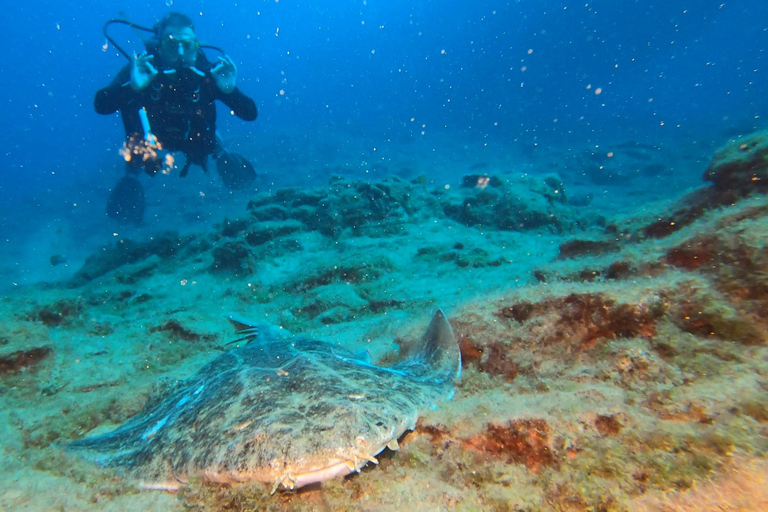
[0, 0, 768, 285]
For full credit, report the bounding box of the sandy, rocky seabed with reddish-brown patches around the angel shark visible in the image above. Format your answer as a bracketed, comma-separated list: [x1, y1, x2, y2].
[0, 130, 768, 511]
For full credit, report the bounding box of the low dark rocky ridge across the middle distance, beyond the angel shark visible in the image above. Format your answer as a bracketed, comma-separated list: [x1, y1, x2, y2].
[242, 174, 600, 243]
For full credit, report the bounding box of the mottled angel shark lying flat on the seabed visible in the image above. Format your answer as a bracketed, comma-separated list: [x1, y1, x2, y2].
[69, 311, 461, 492]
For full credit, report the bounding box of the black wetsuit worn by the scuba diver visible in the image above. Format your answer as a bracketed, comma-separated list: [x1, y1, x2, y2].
[93, 51, 257, 174]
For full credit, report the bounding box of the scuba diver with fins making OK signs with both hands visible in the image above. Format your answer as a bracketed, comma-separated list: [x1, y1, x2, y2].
[94, 12, 257, 224]
